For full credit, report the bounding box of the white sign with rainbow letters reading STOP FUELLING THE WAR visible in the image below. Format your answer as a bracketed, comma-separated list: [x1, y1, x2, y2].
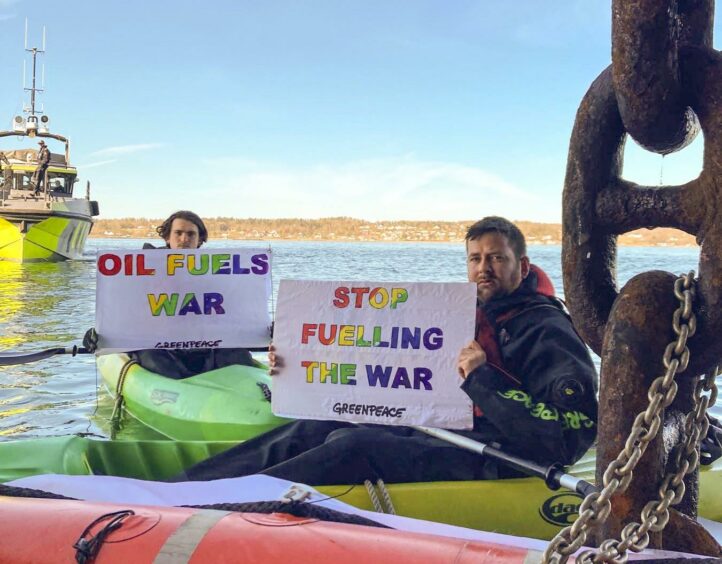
[272, 280, 476, 429]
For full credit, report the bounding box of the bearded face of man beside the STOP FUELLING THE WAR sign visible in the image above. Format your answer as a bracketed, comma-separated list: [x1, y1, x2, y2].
[466, 231, 529, 303]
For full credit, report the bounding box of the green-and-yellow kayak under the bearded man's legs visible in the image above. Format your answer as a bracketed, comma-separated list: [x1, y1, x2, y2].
[0, 437, 722, 539]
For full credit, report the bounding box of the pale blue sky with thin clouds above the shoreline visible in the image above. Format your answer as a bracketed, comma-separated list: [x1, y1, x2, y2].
[0, 0, 719, 222]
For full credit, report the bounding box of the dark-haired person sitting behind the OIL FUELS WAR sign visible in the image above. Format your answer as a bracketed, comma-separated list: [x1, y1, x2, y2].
[83, 210, 256, 380]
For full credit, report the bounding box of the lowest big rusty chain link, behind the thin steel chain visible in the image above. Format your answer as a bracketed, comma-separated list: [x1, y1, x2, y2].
[595, 271, 722, 556]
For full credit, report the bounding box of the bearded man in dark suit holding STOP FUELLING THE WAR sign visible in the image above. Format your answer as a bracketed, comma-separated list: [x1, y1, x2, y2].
[177, 217, 597, 485]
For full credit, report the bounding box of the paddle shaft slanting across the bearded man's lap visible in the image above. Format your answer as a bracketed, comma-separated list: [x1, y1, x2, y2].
[414, 425, 599, 497]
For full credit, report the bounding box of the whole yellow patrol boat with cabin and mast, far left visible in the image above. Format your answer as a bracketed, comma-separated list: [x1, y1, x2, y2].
[0, 37, 99, 263]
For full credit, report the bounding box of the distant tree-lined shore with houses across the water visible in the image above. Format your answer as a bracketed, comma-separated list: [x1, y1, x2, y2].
[91, 217, 695, 246]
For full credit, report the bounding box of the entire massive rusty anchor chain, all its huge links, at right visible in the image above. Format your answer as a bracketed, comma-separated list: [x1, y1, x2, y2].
[562, 0, 722, 548]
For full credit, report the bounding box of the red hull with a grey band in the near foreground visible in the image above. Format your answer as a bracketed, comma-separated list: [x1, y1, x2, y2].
[0, 497, 538, 564]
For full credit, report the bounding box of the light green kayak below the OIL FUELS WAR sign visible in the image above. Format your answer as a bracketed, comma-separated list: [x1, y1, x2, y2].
[97, 354, 288, 441]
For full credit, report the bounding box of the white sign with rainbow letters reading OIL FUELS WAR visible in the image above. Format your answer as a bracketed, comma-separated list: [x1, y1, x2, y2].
[95, 248, 271, 354]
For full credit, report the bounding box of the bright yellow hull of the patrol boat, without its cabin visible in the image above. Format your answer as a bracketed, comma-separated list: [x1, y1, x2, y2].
[0, 200, 95, 263]
